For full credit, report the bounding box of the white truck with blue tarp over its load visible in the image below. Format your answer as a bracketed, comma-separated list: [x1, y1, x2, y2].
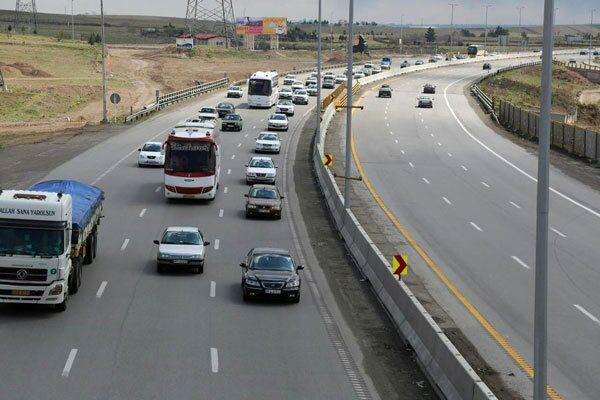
[0, 180, 104, 311]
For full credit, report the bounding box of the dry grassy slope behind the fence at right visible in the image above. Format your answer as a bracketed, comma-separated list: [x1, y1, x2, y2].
[480, 65, 600, 130]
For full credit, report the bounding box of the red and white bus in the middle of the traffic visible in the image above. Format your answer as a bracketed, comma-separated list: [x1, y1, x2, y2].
[165, 126, 221, 200]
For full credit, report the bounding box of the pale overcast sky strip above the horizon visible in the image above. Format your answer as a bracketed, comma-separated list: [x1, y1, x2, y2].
[0, 0, 600, 25]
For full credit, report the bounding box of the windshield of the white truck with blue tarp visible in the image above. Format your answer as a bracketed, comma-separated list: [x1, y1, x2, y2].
[0, 227, 65, 257]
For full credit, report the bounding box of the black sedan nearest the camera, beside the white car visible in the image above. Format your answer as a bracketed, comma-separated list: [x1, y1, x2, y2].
[240, 248, 304, 303]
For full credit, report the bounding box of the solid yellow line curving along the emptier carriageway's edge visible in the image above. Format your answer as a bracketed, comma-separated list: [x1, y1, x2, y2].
[351, 82, 561, 400]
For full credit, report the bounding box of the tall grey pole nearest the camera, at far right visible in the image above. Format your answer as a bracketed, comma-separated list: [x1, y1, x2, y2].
[533, 0, 554, 400]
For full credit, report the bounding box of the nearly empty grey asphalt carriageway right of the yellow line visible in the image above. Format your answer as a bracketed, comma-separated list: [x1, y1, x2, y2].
[354, 54, 600, 399]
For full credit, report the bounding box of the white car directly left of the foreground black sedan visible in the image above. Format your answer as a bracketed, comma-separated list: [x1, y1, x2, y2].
[154, 226, 210, 274]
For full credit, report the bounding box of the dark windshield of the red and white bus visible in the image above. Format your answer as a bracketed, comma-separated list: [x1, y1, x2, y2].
[165, 141, 217, 173]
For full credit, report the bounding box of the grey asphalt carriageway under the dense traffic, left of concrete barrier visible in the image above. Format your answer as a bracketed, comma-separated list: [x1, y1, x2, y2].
[0, 67, 371, 400]
